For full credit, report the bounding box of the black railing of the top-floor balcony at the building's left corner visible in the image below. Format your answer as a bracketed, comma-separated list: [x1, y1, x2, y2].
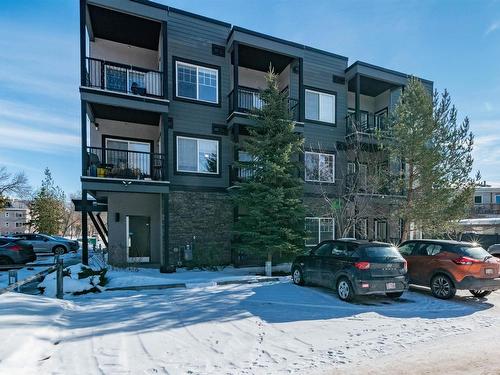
[85, 57, 164, 97]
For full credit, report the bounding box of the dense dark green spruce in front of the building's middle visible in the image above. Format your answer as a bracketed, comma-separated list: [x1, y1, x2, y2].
[233, 69, 304, 268]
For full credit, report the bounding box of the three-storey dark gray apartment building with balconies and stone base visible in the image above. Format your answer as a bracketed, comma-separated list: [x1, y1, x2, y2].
[80, 0, 432, 270]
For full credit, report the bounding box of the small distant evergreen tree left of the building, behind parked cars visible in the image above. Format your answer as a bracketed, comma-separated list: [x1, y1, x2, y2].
[30, 168, 65, 234]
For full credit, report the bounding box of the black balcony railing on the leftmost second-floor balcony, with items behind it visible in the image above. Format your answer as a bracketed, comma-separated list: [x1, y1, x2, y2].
[86, 147, 165, 181]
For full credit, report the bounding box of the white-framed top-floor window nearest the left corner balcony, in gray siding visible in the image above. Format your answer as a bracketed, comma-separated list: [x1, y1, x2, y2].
[176, 61, 219, 104]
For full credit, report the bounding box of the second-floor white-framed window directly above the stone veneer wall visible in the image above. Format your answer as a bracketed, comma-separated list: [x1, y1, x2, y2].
[177, 136, 219, 174]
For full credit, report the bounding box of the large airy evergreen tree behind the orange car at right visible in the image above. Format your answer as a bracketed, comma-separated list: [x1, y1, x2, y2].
[388, 78, 480, 239]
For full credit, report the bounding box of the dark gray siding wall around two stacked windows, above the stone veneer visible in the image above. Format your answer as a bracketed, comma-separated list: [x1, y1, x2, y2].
[168, 13, 232, 191]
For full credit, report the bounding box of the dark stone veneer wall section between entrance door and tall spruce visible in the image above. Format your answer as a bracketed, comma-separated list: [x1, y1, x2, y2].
[169, 191, 233, 263]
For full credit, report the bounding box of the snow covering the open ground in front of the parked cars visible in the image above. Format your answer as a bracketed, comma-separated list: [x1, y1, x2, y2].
[0, 280, 500, 374]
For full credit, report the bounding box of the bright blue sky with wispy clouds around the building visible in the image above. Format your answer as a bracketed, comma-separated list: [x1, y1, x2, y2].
[0, 0, 500, 194]
